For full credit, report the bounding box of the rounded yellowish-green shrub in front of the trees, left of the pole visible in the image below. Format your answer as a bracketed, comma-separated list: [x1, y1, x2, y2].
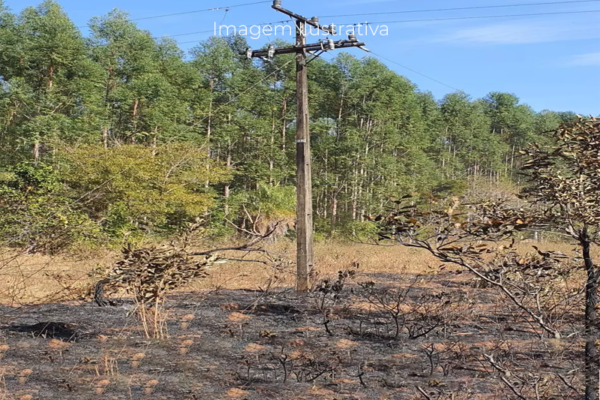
[60, 144, 228, 237]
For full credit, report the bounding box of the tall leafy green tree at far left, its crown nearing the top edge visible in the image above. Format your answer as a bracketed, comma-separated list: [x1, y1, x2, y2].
[0, 0, 87, 161]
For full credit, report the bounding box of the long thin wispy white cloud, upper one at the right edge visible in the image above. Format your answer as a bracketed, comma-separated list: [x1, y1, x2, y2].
[432, 22, 600, 44]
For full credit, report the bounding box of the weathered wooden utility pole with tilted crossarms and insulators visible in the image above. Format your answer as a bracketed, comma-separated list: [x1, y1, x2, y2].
[246, 0, 365, 292]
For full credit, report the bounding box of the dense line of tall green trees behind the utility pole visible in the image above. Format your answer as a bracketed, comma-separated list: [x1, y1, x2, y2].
[0, 0, 575, 247]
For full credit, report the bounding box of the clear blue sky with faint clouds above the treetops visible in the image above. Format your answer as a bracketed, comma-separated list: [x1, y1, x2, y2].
[5, 0, 600, 115]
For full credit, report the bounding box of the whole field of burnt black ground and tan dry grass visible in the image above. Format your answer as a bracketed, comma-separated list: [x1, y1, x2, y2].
[0, 242, 584, 400]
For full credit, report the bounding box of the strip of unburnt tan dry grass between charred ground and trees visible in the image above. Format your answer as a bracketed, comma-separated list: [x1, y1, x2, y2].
[0, 241, 592, 306]
